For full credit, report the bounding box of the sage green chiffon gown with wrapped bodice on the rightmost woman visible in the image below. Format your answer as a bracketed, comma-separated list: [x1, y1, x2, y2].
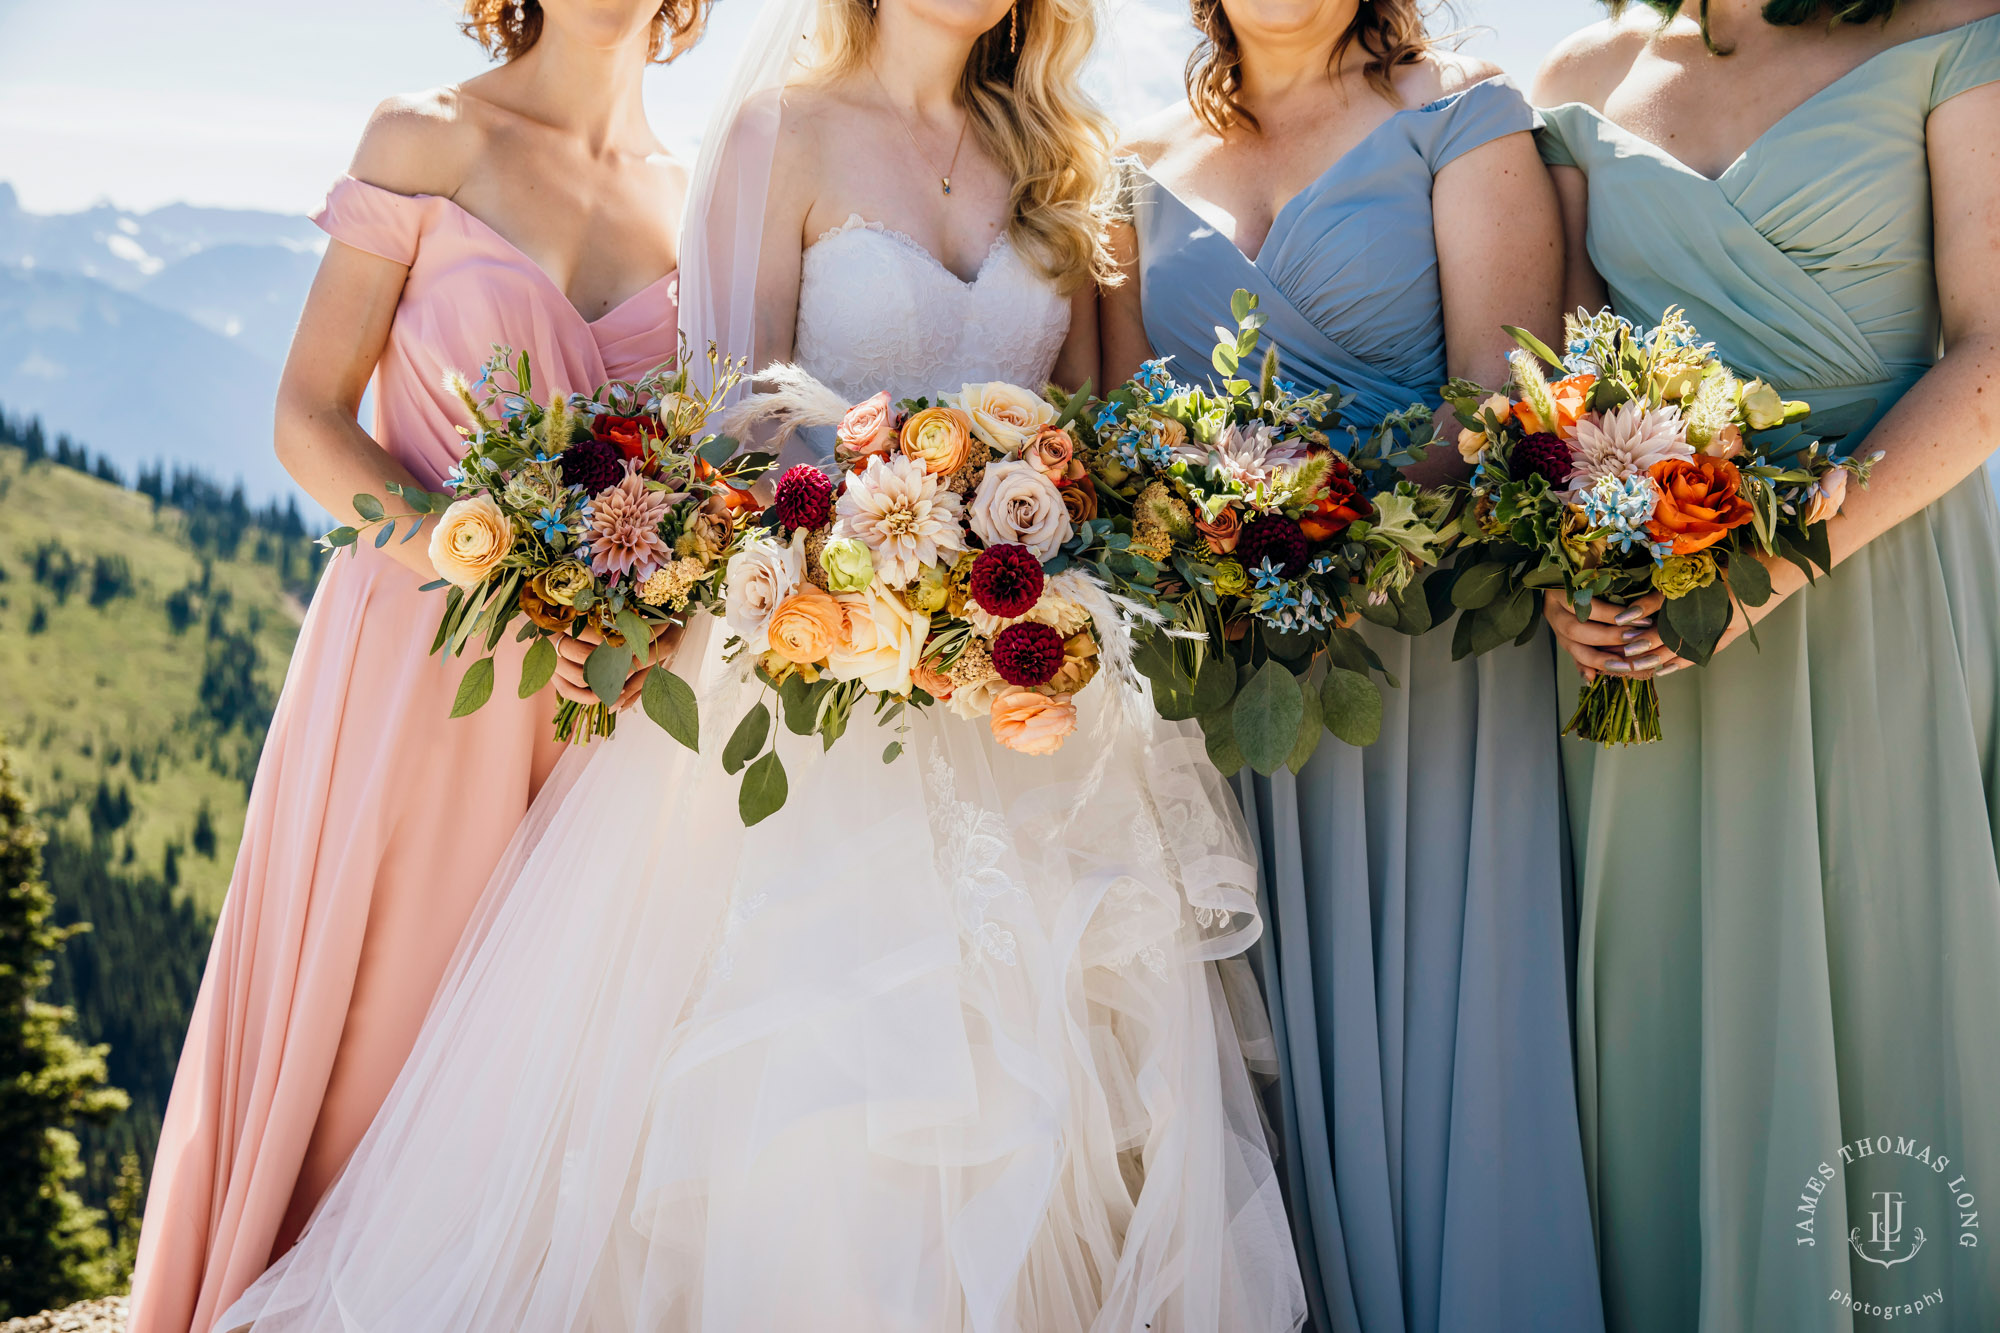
[1542, 16, 2000, 1333]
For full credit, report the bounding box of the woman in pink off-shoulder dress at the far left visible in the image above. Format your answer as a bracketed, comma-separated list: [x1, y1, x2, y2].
[130, 0, 706, 1333]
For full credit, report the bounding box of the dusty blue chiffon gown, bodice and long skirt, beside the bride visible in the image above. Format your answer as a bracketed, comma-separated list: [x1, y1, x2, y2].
[1132, 80, 1602, 1333]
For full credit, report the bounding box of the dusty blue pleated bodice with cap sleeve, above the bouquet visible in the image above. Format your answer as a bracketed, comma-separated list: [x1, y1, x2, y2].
[1132, 78, 1534, 422]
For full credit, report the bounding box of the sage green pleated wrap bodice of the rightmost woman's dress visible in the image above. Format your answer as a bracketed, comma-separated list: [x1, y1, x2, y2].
[1542, 16, 2000, 440]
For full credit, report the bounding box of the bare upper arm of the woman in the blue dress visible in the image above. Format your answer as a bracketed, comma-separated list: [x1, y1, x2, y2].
[1410, 132, 1564, 482]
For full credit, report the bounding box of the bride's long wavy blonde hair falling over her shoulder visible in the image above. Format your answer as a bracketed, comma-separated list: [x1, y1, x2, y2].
[812, 0, 1118, 294]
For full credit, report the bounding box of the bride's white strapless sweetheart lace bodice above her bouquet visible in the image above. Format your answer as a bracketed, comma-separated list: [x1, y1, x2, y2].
[796, 216, 1070, 400]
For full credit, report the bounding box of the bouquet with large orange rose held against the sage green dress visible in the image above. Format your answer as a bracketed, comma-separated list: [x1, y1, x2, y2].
[1442, 308, 1874, 745]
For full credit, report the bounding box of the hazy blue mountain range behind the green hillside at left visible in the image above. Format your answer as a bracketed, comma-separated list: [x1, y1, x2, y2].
[0, 182, 326, 502]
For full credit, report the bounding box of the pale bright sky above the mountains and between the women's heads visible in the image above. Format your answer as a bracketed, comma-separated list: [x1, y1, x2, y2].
[0, 0, 1598, 212]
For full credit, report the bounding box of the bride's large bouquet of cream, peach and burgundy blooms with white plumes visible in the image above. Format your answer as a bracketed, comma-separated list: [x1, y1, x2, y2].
[720, 366, 1130, 825]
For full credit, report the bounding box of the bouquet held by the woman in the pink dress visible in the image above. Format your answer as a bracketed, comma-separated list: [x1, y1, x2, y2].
[322, 346, 768, 749]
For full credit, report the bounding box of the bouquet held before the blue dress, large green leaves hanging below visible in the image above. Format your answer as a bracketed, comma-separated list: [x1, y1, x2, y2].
[1090, 292, 1452, 775]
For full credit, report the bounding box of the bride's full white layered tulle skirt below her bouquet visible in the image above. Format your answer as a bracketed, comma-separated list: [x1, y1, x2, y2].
[218, 626, 1304, 1333]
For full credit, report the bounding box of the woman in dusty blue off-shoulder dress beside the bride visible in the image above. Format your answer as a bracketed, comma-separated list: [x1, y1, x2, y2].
[1104, 0, 1602, 1333]
